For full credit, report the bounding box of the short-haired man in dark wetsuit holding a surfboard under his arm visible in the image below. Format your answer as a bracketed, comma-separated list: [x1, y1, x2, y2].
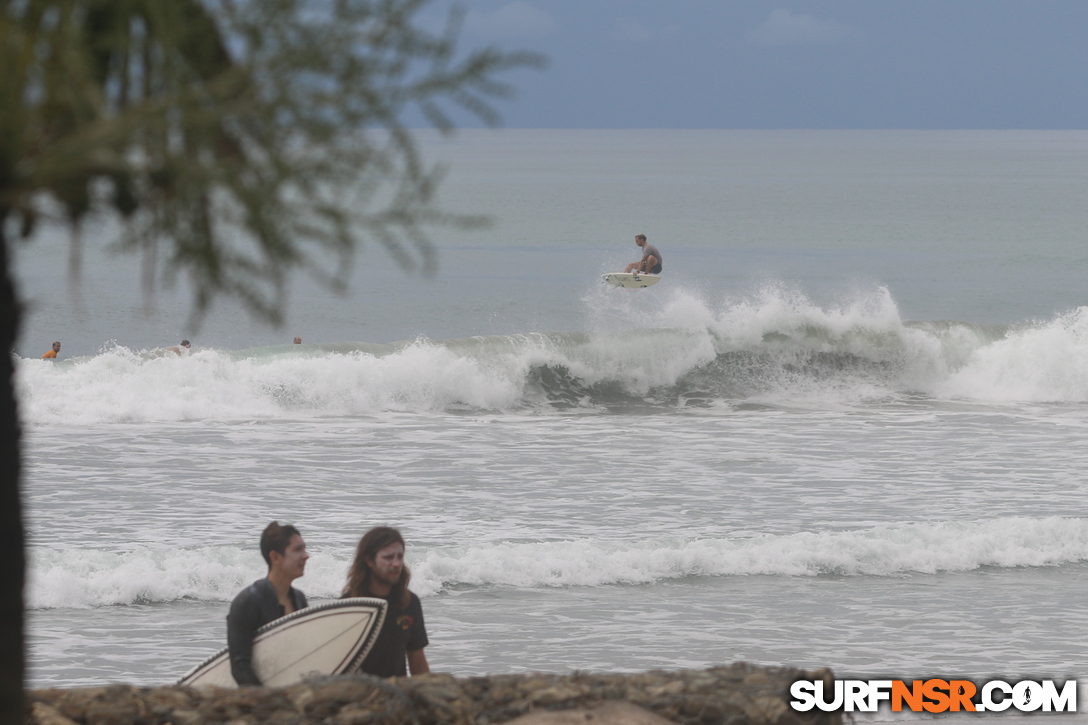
[226, 521, 310, 685]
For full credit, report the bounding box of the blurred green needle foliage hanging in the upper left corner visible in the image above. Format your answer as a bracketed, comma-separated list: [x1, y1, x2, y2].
[0, 0, 544, 322]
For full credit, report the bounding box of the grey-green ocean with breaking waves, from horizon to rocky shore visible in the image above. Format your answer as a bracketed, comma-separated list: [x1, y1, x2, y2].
[8, 130, 1088, 711]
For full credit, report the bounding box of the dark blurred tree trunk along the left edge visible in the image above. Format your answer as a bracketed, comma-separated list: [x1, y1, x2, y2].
[0, 207, 26, 725]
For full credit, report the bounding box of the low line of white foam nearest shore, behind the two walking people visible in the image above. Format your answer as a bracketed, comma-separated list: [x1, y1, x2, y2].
[28, 517, 1088, 609]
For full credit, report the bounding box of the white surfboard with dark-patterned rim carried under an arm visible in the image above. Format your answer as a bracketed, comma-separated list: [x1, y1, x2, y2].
[177, 597, 387, 687]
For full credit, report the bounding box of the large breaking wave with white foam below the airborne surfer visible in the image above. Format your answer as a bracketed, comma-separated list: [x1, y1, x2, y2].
[17, 286, 1088, 426]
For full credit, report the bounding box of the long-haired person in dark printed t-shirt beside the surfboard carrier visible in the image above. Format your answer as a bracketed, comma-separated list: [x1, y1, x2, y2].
[343, 526, 431, 677]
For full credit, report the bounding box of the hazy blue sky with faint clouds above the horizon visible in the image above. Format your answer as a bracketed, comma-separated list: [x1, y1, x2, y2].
[421, 0, 1088, 128]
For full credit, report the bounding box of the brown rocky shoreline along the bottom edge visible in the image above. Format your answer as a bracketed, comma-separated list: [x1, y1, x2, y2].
[27, 662, 842, 725]
